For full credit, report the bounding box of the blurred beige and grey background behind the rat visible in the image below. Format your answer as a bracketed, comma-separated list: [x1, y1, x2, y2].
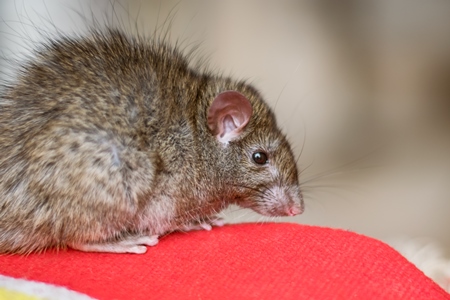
[0, 0, 450, 288]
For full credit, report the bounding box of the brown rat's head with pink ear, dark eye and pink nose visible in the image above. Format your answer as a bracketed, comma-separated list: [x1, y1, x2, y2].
[207, 86, 304, 216]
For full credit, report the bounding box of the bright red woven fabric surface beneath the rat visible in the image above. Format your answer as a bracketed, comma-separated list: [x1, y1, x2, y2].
[0, 224, 450, 300]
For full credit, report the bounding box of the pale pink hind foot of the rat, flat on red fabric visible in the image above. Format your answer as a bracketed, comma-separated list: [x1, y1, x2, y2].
[69, 235, 158, 254]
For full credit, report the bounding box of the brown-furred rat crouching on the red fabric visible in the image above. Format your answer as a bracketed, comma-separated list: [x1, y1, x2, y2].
[0, 29, 304, 254]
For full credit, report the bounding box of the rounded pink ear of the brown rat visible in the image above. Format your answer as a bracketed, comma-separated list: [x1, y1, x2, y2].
[208, 91, 253, 144]
